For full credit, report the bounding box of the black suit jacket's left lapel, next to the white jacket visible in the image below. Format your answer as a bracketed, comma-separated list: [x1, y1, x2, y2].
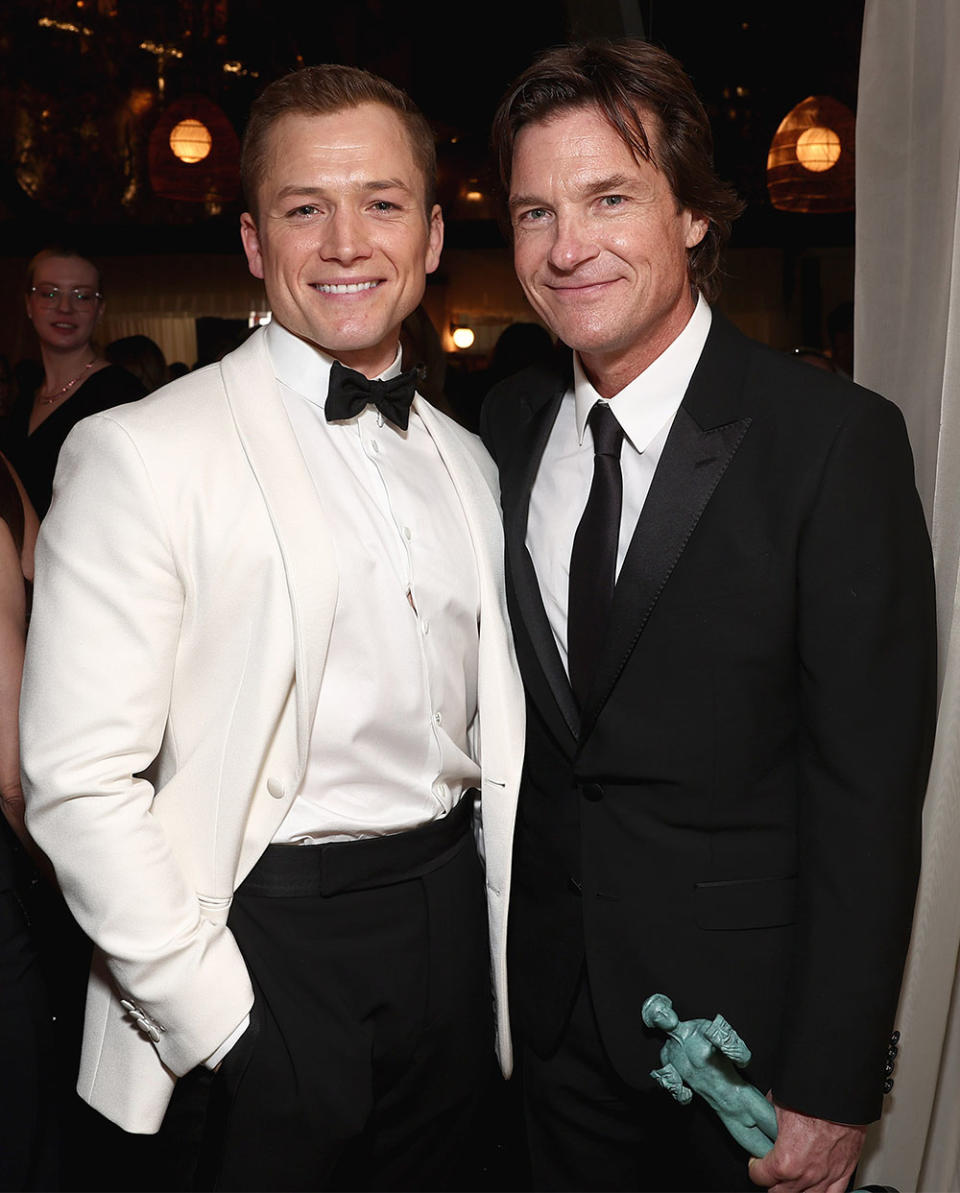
[503, 376, 580, 737]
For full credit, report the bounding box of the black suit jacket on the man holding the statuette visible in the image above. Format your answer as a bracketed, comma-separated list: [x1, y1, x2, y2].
[482, 313, 936, 1123]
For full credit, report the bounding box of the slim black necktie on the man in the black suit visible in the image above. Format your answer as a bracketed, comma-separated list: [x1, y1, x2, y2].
[566, 402, 624, 709]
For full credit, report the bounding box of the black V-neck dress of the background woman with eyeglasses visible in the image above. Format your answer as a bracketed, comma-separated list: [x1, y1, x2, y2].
[4, 365, 147, 518]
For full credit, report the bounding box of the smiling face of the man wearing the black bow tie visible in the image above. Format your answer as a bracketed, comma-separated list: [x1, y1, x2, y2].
[241, 104, 444, 377]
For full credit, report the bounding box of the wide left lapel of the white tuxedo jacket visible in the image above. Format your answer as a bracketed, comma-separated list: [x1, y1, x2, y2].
[221, 332, 337, 781]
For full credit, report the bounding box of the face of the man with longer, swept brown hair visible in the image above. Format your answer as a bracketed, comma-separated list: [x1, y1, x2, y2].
[510, 106, 707, 397]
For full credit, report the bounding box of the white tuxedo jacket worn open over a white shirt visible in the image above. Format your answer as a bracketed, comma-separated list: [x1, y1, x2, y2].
[21, 333, 524, 1132]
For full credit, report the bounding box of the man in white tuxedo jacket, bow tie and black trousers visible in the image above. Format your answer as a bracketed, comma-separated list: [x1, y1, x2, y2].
[21, 67, 524, 1189]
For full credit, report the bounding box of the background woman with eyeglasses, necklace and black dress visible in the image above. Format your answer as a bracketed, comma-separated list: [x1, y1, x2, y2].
[5, 247, 145, 518]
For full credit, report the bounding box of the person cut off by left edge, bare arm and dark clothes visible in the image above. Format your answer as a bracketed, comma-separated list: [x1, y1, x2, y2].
[0, 456, 60, 1189]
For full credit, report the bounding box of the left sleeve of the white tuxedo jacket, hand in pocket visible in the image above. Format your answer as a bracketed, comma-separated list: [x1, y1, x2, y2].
[20, 414, 253, 1074]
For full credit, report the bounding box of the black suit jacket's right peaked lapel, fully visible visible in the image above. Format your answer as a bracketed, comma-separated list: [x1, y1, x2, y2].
[581, 311, 751, 740]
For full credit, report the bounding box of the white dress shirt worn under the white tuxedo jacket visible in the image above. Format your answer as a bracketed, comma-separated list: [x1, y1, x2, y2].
[267, 322, 479, 842]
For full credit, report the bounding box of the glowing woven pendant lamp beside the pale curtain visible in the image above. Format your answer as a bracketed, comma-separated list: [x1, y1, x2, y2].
[767, 95, 855, 214]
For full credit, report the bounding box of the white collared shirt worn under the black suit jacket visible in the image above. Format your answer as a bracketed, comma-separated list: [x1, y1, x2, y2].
[526, 295, 712, 672]
